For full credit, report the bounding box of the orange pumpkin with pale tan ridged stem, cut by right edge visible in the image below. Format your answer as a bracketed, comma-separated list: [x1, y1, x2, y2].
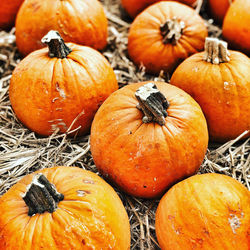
[170, 38, 250, 142]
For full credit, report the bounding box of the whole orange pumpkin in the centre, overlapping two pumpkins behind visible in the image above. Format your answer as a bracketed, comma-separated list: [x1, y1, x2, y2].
[90, 82, 208, 198]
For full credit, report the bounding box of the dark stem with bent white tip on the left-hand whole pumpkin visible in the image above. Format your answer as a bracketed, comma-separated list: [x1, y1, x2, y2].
[41, 30, 72, 59]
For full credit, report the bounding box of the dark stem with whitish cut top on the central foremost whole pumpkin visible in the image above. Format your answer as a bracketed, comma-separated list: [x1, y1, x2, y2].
[135, 82, 169, 126]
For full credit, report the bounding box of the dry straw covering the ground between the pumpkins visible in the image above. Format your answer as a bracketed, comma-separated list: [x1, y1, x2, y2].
[0, 0, 250, 249]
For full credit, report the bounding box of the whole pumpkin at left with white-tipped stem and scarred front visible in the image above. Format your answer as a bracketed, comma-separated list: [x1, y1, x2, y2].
[9, 31, 118, 136]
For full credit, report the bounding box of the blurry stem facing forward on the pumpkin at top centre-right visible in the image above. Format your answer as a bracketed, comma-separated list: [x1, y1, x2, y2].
[160, 17, 185, 44]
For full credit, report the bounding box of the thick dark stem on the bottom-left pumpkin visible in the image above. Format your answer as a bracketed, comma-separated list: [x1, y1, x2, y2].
[22, 174, 64, 216]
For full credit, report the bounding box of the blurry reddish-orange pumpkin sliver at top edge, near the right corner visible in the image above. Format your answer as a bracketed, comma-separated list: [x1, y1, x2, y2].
[208, 0, 233, 23]
